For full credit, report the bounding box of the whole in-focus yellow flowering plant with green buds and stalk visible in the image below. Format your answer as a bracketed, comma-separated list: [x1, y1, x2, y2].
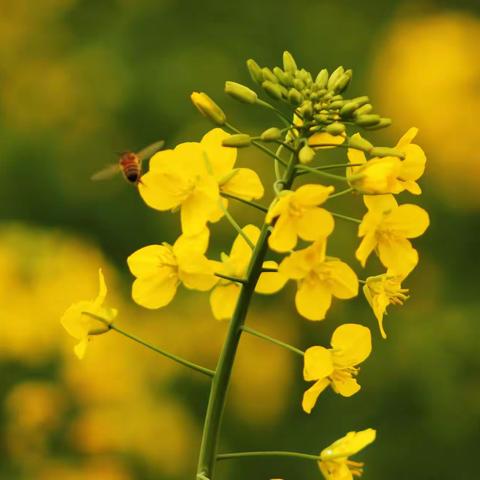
[63, 52, 429, 480]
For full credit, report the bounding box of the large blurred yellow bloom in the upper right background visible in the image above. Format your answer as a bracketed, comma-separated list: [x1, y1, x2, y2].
[371, 10, 480, 208]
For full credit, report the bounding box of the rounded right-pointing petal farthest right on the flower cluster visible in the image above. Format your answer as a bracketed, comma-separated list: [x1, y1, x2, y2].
[382, 204, 430, 238]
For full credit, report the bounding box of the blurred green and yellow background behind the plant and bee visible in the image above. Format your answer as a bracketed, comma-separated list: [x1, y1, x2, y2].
[0, 0, 480, 480]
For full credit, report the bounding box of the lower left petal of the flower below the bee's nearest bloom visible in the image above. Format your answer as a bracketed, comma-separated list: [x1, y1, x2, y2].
[132, 275, 178, 309]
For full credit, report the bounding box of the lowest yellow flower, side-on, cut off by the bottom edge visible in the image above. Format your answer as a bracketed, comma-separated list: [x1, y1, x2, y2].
[318, 428, 376, 480]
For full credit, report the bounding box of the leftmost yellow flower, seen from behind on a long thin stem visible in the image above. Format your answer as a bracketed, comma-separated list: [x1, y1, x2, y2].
[60, 269, 118, 359]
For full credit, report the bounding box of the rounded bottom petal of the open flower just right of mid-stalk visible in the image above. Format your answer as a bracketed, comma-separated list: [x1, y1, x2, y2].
[295, 279, 332, 320]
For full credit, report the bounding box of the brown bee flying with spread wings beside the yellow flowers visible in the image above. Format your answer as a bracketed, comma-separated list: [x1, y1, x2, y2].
[91, 140, 165, 185]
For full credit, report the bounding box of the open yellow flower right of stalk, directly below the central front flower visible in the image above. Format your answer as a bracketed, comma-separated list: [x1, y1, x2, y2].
[279, 240, 358, 320]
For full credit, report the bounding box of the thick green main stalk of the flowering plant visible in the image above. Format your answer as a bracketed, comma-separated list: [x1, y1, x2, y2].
[197, 155, 297, 480]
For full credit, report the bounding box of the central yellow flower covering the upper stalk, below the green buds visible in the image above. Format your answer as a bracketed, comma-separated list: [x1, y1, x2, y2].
[266, 184, 335, 252]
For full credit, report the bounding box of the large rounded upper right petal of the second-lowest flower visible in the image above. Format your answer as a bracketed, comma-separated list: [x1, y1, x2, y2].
[331, 323, 372, 368]
